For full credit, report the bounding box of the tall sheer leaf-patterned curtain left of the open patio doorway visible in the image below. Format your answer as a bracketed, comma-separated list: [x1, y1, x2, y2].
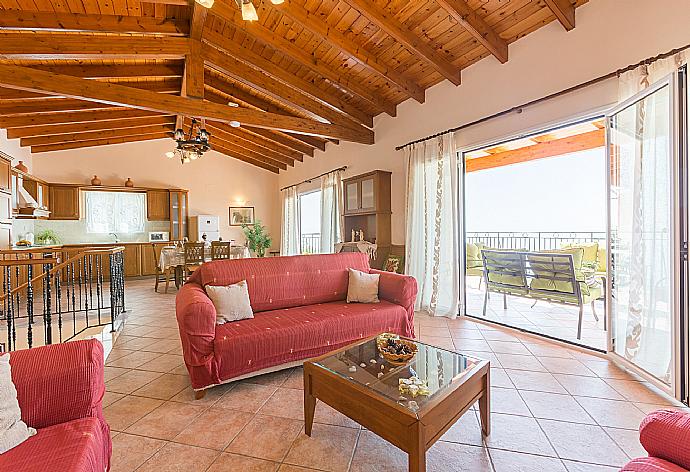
[405, 133, 465, 318]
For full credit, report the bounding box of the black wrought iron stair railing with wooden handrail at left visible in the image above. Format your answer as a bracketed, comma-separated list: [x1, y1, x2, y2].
[0, 247, 125, 351]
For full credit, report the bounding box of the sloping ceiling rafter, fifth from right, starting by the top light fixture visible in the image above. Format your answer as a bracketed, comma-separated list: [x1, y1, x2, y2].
[211, 4, 396, 116]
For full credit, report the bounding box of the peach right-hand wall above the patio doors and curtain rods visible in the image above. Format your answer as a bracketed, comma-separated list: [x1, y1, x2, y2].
[279, 0, 690, 244]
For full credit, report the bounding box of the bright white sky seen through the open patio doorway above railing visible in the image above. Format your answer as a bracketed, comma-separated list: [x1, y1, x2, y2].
[465, 147, 606, 233]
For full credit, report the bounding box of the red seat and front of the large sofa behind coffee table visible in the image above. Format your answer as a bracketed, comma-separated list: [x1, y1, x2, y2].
[214, 300, 414, 381]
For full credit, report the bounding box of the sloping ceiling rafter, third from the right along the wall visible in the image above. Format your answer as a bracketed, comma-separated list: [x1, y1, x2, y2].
[346, 0, 460, 85]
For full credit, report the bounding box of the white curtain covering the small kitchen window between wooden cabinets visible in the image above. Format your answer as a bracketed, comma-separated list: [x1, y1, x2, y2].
[84, 192, 146, 234]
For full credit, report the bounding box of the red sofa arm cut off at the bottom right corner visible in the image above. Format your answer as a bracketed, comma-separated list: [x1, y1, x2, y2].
[621, 410, 690, 472]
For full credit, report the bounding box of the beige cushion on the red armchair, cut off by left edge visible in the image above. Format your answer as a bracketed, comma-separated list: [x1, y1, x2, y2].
[0, 354, 36, 454]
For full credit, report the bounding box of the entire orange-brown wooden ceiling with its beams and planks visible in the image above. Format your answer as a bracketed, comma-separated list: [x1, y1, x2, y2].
[0, 0, 587, 173]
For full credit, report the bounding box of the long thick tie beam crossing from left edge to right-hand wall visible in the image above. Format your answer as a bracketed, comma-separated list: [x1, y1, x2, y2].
[0, 64, 374, 144]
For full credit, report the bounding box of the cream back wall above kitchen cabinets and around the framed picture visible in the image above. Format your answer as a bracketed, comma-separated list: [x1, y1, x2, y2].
[33, 139, 280, 247]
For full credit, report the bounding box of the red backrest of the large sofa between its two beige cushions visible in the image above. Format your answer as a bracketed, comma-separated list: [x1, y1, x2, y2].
[188, 252, 369, 313]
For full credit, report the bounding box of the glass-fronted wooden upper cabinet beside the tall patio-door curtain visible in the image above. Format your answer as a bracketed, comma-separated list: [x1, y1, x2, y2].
[343, 170, 391, 215]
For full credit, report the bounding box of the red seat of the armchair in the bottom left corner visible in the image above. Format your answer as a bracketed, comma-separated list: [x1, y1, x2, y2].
[0, 417, 110, 472]
